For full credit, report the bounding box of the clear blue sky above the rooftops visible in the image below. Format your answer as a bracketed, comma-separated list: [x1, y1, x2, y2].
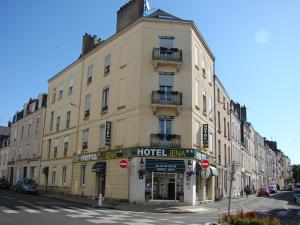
[0, 0, 300, 164]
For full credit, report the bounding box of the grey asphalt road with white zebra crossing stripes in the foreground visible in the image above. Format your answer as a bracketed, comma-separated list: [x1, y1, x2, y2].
[0, 190, 300, 225]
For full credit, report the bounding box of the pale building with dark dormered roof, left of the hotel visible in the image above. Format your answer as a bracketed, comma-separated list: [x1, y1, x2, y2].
[8, 94, 47, 185]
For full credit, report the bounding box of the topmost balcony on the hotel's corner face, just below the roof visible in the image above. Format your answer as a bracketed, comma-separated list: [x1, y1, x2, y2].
[152, 47, 182, 72]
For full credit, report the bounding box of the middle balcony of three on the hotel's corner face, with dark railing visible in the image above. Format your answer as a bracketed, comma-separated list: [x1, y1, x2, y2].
[151, 91, 182, 115]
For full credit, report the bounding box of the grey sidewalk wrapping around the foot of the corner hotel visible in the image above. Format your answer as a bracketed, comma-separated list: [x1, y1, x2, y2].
[40, 192, 214, 213]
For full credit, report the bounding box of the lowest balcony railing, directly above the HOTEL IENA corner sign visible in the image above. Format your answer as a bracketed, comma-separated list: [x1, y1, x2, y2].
[150, 134, 181, 148]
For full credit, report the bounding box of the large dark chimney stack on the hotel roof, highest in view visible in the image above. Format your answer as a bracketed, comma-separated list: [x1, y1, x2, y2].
[117, 0, 144, 33]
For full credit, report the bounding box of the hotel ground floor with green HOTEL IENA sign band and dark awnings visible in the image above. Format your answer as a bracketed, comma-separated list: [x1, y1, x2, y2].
[72, 148, 217, 205]
